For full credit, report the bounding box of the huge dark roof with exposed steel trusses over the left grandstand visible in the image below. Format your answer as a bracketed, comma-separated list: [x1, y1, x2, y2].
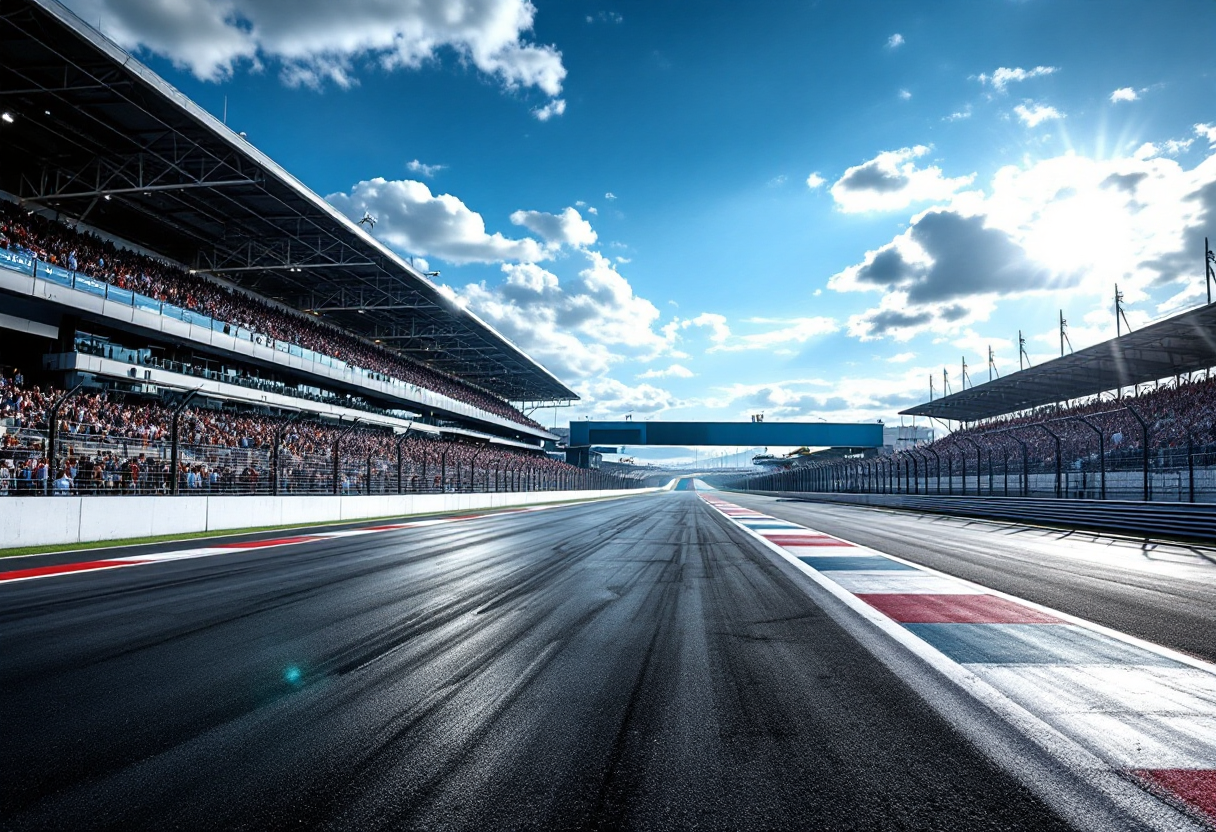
[0, 0, 578, 403]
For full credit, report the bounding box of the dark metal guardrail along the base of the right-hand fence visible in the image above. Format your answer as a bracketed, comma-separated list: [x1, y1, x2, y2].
[728, 489, 1216, 543]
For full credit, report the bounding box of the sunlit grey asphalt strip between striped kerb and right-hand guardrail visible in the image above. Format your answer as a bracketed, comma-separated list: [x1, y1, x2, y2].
[722, 493, 1216, 662]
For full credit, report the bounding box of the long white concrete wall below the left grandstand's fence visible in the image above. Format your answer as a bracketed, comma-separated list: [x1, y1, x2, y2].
[0, 488, 664, 549]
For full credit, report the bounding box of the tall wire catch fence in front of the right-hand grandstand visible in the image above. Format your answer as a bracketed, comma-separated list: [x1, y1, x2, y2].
[730, 406, 1216, 502]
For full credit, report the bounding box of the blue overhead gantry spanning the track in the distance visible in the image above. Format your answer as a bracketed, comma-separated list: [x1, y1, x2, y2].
[570, 420, 883, 467]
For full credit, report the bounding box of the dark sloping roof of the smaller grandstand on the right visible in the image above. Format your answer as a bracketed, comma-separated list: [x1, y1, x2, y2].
[901, 304, 1216, 422]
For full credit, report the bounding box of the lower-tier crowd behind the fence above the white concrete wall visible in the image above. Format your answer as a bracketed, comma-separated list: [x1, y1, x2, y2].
[0, 370, 580, 495]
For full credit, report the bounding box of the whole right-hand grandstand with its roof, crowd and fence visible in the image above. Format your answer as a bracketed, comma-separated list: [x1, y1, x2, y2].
[724, 296, 1216, 502]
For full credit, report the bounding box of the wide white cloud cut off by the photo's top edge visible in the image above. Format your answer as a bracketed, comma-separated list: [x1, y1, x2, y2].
[67, 0, 565, 97]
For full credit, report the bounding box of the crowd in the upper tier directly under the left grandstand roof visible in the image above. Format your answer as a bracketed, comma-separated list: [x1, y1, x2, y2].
[0, 201, 540, 427]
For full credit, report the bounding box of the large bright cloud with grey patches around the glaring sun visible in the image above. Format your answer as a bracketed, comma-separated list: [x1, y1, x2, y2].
[828, 144, 1216, 341]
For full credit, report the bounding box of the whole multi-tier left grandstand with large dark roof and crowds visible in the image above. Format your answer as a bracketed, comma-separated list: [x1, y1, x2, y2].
[0, 0, 627, 494]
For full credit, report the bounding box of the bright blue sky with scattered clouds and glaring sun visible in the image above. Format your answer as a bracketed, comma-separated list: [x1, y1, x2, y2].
[68, 0, 1216, 447]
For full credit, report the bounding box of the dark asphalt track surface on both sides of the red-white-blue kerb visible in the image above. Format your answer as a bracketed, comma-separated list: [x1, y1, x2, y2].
[0, 493, 1216, 831]
